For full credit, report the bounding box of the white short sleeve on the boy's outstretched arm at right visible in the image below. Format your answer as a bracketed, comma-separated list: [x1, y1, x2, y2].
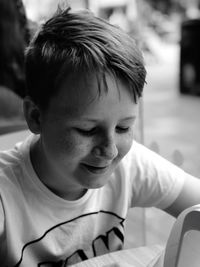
[125, 141, 187, 209]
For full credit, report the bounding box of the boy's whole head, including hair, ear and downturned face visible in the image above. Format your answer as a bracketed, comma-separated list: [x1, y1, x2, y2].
[24, 7, 148, 199]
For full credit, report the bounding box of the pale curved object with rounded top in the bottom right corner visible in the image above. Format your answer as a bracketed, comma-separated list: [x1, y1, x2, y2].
[164, 205, 200, 267]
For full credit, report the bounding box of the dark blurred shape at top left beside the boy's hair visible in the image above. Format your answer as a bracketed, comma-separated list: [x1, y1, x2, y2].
[0, 0, 29, 97]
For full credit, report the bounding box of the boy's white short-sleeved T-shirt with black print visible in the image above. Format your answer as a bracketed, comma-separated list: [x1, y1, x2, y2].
[0, 135, 187, 267]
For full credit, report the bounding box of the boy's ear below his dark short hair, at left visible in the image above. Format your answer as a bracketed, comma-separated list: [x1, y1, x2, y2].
[23, 96, 41, 134]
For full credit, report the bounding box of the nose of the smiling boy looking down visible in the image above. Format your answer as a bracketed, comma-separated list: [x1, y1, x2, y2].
[93, 133, 118, 160]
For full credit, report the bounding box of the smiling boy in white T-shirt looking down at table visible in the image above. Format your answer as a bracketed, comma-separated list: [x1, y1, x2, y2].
[0, 6, 200, 267]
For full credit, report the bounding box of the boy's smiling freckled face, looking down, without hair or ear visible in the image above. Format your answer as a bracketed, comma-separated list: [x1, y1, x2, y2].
[35, 72, 137, 198]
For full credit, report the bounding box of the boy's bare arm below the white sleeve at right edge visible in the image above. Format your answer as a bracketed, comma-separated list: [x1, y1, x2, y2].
[165, 175, 200, 217]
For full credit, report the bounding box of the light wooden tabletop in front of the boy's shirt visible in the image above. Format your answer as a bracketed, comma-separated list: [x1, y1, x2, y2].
[72, 245, 164, 267]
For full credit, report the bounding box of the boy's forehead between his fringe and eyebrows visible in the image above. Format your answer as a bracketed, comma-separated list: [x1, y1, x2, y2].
[47, 73, 134, 117]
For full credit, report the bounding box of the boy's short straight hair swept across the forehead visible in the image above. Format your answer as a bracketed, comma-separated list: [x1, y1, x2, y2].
[25, 8, 146, 108]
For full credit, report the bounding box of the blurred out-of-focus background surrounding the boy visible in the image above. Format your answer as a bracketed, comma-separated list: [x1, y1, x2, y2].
[0, 0, 200, 251]
